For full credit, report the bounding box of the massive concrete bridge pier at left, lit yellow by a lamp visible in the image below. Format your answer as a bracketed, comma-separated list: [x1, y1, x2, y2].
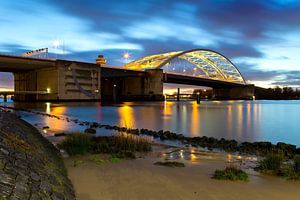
[14, 60, 101, 101]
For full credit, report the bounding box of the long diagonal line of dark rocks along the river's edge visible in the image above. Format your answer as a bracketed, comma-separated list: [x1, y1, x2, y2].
[0, 106, 300, 158]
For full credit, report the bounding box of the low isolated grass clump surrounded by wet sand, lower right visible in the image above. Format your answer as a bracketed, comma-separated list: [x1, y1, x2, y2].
[212, 166, 249, 181]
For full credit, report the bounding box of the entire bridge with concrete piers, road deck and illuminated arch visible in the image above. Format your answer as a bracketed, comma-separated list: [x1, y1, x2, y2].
[0, 49, 254, 101]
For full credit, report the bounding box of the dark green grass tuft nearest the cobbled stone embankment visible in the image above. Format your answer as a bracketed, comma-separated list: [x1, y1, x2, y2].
[58, 133, 92, 155]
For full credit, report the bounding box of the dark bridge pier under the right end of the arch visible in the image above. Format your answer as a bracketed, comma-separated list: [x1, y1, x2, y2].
[213, 85, 255, 100]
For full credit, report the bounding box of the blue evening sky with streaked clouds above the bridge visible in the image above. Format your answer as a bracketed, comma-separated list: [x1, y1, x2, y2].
[0, 0, 300, 88]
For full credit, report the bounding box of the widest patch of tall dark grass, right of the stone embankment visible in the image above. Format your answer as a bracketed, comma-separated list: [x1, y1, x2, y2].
[58, 133, 152, 158]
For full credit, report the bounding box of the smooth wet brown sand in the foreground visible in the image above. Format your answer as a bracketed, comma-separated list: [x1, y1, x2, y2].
[65, 146, 300, 200]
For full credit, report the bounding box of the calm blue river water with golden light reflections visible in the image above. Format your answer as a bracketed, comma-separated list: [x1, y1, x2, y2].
[0, 100, 300, 146]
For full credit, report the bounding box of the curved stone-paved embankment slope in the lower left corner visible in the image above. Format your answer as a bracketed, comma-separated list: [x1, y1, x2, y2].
[0, 109, 75, 200]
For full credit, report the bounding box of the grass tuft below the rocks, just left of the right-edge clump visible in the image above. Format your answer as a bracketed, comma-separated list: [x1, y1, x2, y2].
[257, 155, 283, 172]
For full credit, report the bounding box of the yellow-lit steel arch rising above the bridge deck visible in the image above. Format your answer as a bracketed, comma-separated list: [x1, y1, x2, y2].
[124, 49, 246, 85]
